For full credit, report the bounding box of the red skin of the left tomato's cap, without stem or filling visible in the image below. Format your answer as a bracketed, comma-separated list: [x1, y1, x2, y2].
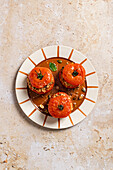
[28, 67, 53, 88]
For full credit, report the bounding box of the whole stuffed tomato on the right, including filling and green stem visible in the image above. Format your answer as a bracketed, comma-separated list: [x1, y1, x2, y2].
[59, 63, 85, 88]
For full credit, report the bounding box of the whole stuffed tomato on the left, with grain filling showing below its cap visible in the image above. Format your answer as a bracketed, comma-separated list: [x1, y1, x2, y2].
[27, 67, 54, 94]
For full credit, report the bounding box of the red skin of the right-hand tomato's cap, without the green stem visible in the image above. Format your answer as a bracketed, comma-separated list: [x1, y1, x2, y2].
[62, 63, 85, 86]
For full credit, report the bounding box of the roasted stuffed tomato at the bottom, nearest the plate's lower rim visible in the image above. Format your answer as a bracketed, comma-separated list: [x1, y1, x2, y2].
[48, 92, 73, 118]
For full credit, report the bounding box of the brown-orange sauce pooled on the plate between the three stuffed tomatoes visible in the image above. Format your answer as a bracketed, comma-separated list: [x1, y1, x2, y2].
[27, 57, 87, 116]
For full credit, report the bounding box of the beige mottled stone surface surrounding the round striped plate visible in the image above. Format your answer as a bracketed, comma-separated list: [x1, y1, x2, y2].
[0, 0, 113, 170]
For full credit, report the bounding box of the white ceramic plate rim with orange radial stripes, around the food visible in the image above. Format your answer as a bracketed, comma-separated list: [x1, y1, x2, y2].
[15, 46, 98, 129]
